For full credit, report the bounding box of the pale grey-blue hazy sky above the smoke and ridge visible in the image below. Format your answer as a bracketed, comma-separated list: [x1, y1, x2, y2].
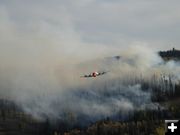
[0, 0, 180, 50]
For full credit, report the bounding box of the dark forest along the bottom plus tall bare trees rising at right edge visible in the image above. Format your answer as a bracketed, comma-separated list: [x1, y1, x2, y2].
[0, 75, 180, 135]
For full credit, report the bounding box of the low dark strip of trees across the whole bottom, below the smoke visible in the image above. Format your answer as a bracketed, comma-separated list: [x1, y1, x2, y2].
[0, 93, 180, 135]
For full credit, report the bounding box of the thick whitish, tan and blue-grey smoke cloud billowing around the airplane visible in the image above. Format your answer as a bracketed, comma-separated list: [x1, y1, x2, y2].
[0, 3, 180, 126]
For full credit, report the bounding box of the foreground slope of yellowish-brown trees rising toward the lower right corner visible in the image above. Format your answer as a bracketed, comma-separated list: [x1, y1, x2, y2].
[61, 105, 180, 135]
